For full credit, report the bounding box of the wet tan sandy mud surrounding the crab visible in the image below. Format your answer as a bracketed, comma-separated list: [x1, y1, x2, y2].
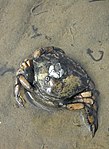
[0, 0, 109, 149]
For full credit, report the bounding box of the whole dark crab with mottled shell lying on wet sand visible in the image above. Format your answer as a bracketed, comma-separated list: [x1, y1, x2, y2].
[14, 47, 99, 137]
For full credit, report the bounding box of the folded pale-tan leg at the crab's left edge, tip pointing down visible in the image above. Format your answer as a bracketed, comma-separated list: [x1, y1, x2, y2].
[14, 59, 33, 106]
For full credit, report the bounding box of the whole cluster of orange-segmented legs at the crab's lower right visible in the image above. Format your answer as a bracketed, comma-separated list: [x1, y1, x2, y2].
[66, 91, 98, 137]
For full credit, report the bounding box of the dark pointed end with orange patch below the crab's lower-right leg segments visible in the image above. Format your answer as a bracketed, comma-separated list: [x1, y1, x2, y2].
[85, 102, 98, 137]
